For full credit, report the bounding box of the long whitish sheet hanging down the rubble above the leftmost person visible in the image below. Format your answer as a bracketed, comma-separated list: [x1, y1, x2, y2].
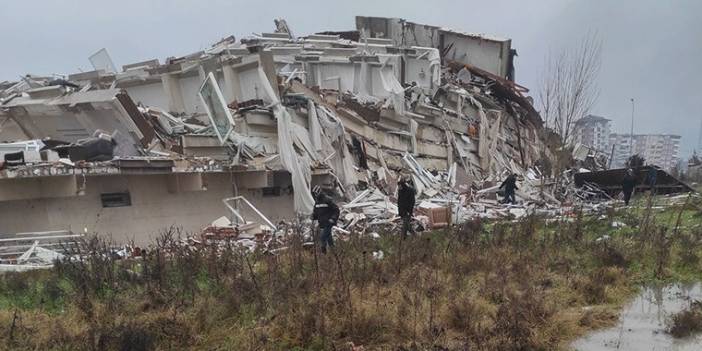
[258, 67, 314, 216]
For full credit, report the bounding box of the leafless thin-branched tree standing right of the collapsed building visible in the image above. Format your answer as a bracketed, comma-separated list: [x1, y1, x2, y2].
[538, 33, 602, 144]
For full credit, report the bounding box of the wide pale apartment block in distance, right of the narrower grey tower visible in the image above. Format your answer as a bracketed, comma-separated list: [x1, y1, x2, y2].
[609, 133, 680, 171]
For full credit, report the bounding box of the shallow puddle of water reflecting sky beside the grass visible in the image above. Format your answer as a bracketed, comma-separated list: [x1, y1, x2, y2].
[572, 284, 702, 351]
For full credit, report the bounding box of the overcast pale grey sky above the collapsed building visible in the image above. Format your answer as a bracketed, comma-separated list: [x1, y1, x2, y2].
[0, 0, 702, 155]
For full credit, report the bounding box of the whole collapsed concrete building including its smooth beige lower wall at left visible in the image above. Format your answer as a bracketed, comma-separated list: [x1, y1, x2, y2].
[0, 17, 558, 248]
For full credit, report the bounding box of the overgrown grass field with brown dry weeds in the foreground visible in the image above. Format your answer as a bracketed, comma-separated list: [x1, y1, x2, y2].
[0, 196, 702, 351]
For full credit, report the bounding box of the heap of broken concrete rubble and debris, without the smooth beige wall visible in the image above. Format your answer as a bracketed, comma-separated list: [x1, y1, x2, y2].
[0, 17, 692, 264]
